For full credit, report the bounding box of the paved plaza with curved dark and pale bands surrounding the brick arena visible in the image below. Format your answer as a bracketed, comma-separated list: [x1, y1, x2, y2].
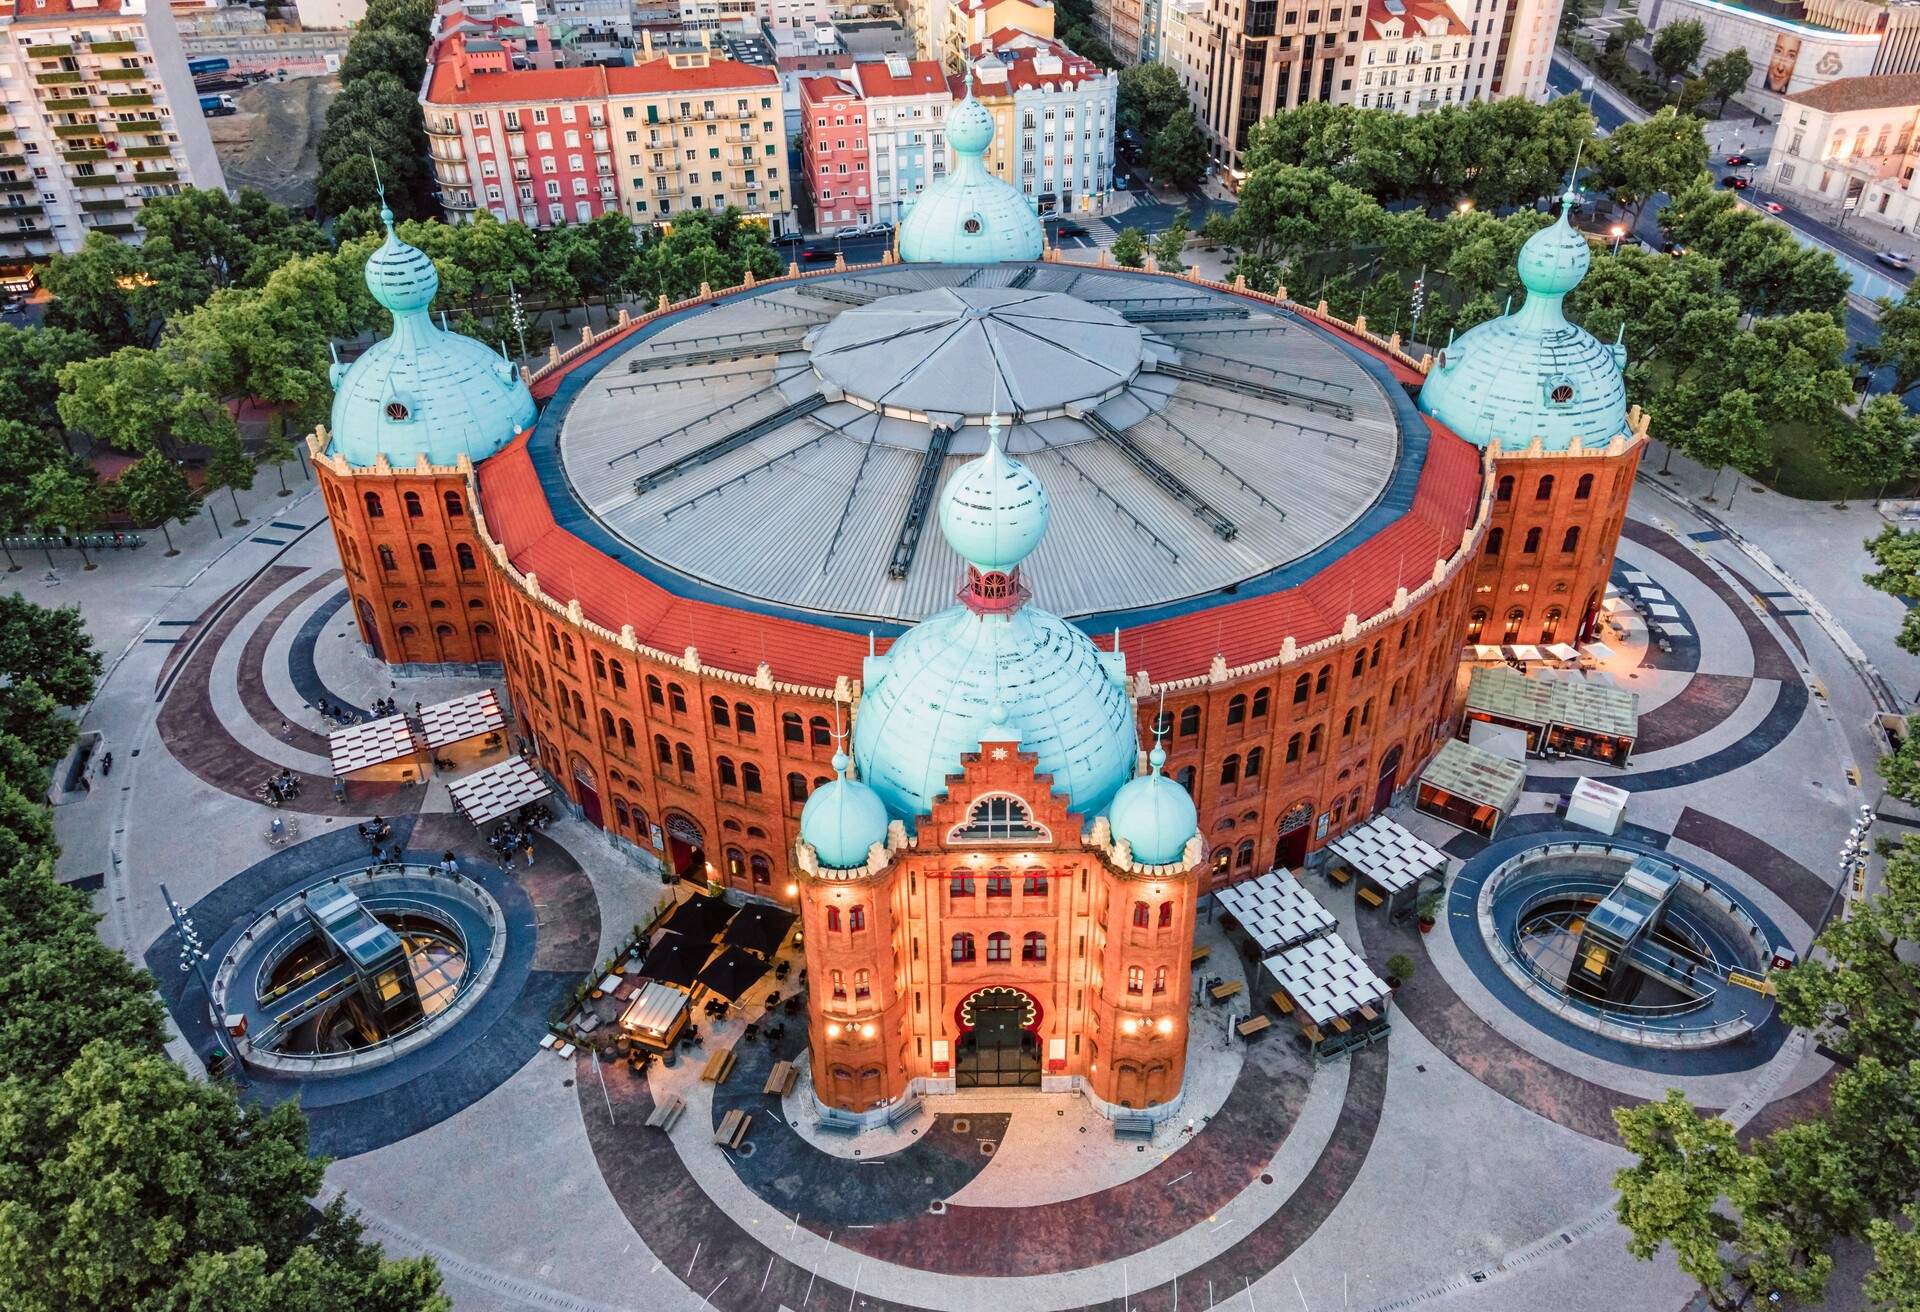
[30, 472, 1910, 1312]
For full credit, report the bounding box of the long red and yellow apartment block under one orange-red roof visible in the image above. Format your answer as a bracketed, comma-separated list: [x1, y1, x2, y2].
[420, 33, 791, 234]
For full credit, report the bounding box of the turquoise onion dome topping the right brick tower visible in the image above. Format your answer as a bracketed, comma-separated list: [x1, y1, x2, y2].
[1419, 194, 1626, 451]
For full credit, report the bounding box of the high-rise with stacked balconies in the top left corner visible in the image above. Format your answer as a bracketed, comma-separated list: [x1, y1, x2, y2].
[0, 0, 225, 259]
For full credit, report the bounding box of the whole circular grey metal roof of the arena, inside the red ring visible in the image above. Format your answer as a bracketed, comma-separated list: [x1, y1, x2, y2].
[561, 265, 1400, 622]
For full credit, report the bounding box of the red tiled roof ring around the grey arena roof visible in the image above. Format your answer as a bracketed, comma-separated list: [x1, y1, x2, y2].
[499, 291, 1480, 686]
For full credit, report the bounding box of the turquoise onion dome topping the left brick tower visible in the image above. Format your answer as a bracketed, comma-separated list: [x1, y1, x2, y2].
[328, 207, 534, 469]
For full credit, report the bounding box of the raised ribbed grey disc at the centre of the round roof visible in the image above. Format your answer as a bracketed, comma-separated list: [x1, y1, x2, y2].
[808, 286, 1142, 421]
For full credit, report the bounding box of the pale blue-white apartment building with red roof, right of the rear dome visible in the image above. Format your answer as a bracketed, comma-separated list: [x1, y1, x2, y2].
[967, 29, 1119, 213]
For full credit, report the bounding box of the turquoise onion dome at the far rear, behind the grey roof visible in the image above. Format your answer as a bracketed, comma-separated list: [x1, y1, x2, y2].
[900, 77, 1046, 265]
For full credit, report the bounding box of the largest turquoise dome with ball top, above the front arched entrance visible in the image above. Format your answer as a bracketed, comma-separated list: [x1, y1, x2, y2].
[852, 420, 1139, 828]
